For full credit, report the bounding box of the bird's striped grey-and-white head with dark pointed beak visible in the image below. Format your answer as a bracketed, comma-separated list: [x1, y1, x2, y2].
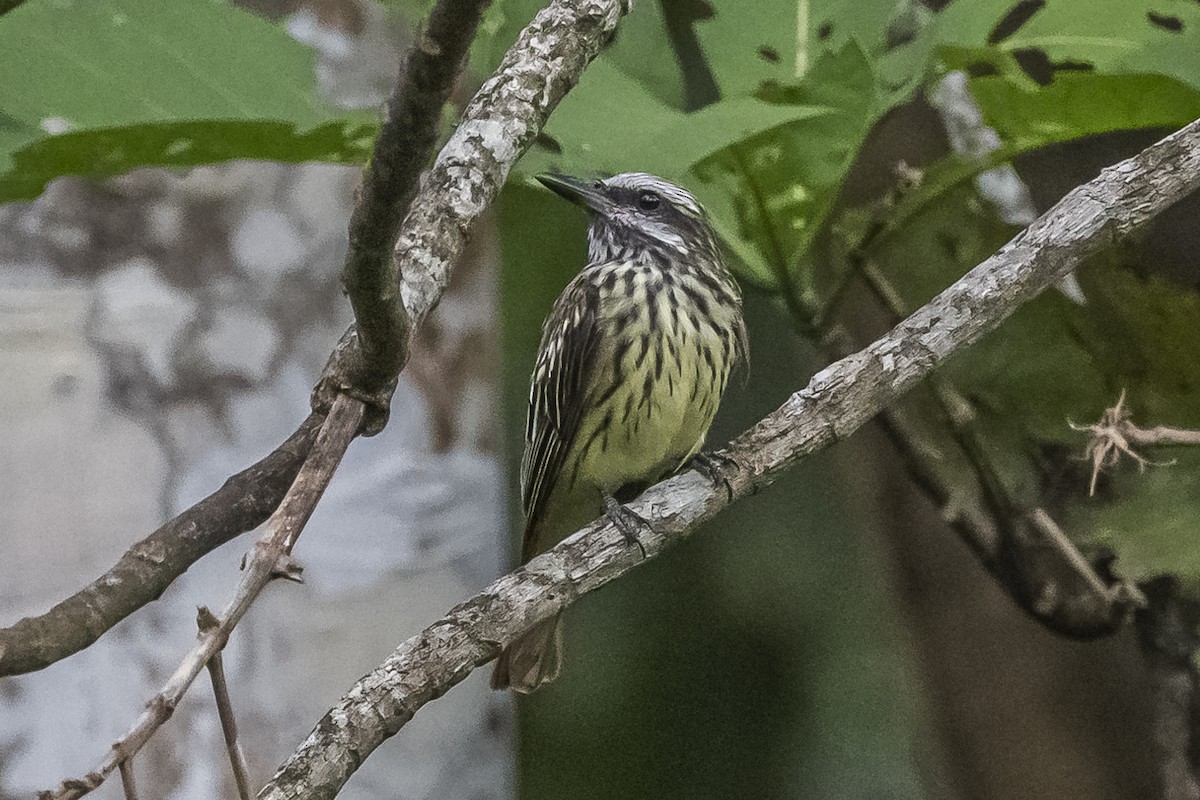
[538, 173, 719, 263]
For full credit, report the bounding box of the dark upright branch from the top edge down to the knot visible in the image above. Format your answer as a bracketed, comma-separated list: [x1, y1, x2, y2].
[342, 0, 490, 398]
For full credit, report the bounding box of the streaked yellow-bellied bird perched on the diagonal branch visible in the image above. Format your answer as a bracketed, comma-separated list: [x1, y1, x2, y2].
[492, 173, 749, 693]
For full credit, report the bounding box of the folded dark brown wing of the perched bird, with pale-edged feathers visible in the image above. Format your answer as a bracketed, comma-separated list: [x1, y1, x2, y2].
[521, 273, 600, 560]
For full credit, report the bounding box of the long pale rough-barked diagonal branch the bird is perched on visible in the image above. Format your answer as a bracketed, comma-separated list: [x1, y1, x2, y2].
[259, 121, 1200, 800]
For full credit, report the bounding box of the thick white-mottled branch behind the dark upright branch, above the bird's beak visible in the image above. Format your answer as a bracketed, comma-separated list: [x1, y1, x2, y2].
[313, 0, 629, 434]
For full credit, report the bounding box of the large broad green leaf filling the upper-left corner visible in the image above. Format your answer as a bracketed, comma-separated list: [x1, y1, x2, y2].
[0, 0, 376, 201]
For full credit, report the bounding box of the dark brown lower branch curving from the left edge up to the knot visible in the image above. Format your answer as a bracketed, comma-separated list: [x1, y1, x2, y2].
[0, 414, 325, 678]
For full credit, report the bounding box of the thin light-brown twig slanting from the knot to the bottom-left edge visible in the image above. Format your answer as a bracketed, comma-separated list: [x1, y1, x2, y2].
[38, 395, 364, 800]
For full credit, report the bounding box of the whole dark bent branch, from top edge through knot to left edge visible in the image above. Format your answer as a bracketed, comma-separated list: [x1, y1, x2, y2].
[0, 0, 492, 676]
